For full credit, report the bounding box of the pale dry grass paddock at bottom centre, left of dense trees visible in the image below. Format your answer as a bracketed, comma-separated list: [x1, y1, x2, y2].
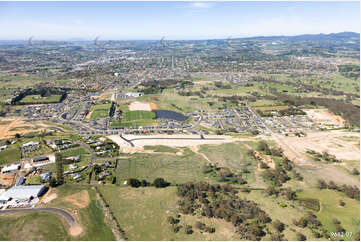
[99, 185, 239, 241]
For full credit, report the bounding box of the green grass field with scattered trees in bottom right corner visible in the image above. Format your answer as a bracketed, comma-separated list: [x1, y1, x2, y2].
[297, 189, 360, 240]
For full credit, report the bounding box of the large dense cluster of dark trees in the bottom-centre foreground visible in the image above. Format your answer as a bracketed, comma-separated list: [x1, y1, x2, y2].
[177, 182, 272, 240]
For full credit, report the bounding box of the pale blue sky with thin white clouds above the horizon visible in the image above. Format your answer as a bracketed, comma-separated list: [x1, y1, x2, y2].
[0, 1, 360, 40]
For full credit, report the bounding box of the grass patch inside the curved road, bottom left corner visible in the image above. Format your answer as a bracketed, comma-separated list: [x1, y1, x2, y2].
[0, 212, 70, 241]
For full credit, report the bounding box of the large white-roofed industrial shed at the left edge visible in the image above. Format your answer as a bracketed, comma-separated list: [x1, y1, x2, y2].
[0, 185, 47, 201]
